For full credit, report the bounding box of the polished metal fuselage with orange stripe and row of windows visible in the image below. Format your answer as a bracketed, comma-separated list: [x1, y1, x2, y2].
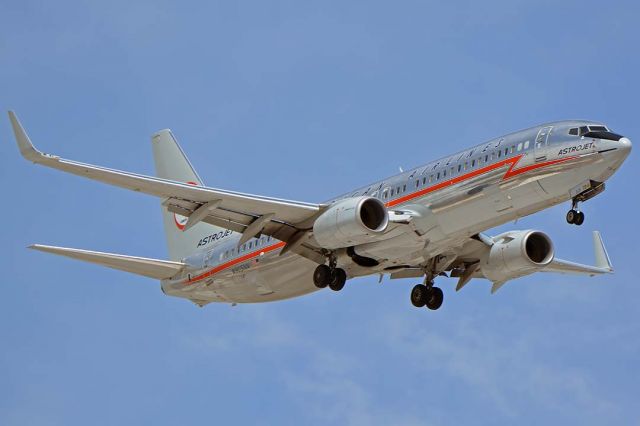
[162, 121, 631, 304]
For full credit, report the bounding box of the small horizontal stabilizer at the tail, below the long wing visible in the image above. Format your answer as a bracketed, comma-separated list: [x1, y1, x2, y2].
[29, 244, 185, 280]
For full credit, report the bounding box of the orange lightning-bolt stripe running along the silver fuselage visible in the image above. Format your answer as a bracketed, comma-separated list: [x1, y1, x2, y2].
[186, 154, 578, 284]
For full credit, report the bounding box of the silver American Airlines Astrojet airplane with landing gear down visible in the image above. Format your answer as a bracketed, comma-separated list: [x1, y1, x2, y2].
[9, 111, 631, 310]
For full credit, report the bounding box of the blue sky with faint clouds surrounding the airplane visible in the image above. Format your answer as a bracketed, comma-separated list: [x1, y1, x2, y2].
[0, 0, 640, 425]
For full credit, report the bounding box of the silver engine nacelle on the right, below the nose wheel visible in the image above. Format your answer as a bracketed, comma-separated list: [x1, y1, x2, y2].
[481, 230, 554, 282]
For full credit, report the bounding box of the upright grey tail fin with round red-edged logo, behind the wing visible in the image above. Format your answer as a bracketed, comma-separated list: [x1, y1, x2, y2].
[151, 129, 225, 261]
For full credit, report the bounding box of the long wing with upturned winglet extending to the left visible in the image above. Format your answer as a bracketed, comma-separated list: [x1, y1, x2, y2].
[9, 111, 326, 263]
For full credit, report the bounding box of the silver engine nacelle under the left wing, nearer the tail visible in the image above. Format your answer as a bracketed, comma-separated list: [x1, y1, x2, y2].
[313, 197, 389, 249]
